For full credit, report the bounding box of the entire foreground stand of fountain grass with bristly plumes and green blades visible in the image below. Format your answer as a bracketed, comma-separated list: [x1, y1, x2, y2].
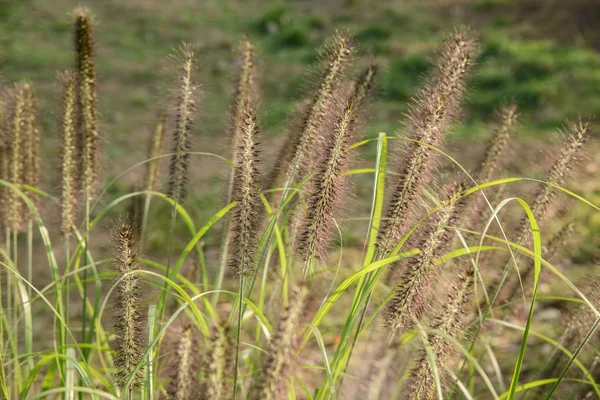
[0, 9, 600, 400]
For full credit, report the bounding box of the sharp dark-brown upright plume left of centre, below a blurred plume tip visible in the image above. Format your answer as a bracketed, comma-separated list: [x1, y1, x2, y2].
[229, 105, 262, 275]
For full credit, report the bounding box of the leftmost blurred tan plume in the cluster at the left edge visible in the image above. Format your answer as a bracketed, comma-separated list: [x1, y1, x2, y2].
[5, 85, 26, 231]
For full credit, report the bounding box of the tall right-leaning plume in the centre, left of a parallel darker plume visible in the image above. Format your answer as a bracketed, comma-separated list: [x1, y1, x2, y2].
[285, 32, 353, 185]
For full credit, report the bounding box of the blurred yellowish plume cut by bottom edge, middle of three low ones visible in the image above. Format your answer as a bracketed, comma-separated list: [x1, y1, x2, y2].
[200, 326, 235, 400]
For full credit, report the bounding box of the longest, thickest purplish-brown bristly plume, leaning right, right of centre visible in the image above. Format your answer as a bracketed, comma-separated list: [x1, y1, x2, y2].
[378, 29, 478, 257]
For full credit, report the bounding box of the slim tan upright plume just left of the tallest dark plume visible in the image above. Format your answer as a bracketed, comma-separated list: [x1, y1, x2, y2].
[59, 71, 77, 235]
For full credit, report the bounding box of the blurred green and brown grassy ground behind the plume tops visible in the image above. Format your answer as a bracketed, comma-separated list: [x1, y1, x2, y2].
[0, 0, 600, 260]
